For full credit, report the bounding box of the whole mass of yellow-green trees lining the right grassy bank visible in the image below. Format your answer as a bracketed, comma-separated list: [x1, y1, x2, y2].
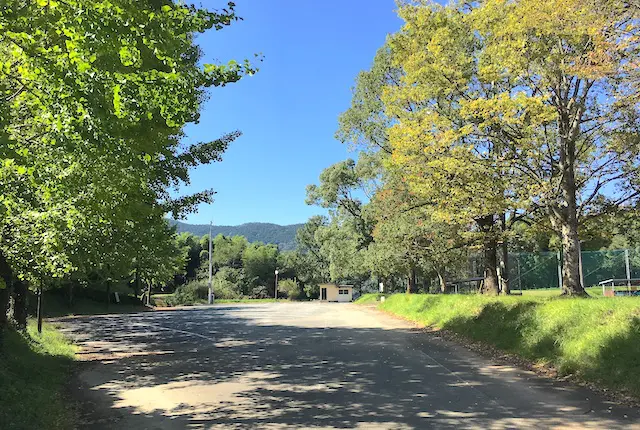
[307, 0, 640, 295]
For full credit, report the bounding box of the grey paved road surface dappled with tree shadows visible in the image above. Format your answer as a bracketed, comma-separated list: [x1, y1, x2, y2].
[66, 303, 640, 429]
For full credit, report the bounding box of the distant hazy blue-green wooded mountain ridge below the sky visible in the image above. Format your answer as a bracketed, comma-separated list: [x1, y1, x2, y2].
[170, 220, 303, 251]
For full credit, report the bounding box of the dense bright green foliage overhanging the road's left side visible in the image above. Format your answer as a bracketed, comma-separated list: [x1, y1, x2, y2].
[0, 0, 253, 332]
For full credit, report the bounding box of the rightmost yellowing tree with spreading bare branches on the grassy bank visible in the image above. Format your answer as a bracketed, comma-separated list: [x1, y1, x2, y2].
[464, 0, 640, 295]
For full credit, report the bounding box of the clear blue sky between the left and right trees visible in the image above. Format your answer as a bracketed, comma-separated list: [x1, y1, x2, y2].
[181, 0, 401, 225]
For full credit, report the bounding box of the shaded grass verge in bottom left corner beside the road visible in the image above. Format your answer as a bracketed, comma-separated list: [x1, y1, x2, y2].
[0, 321, 75, 430]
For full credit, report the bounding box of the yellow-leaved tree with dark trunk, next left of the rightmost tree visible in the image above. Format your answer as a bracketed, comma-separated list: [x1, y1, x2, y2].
[383, 2, 517, 294]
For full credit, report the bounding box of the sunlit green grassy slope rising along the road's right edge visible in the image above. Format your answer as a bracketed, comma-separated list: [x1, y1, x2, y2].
[358, 294, 640, 397]
